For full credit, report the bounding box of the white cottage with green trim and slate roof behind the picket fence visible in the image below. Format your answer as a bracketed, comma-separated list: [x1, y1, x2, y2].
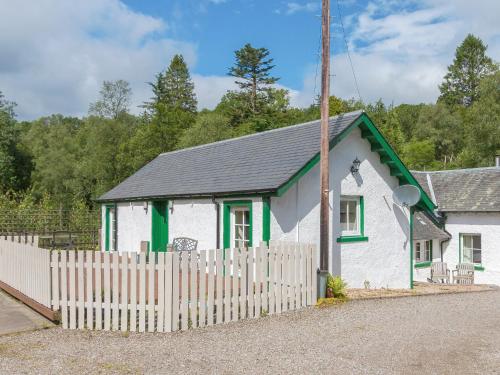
[99, 111, 435, 288]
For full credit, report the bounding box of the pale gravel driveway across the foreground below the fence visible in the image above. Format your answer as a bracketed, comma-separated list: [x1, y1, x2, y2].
[0, 290, 500, 375]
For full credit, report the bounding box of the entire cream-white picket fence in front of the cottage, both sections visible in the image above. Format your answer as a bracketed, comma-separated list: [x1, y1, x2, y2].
[0, 239, 317, 332]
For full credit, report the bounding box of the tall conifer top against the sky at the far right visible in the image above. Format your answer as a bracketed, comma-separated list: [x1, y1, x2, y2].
[439, 34, 498, 107]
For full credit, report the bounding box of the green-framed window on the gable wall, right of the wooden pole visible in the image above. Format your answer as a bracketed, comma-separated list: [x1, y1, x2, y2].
[337, 196, 368, 242]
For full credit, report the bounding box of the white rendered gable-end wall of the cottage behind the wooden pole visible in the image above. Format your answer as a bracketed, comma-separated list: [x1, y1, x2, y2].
[271, 129, 410, 288]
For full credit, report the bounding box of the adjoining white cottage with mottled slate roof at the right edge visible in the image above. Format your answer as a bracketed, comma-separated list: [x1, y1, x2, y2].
[413, 167, 500, 285]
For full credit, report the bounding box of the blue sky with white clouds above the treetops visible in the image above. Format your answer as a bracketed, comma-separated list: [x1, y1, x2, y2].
[0, 0, 500, 119]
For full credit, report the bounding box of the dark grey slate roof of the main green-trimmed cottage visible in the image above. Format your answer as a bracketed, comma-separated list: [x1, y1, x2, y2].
[98, 111, 363, 201]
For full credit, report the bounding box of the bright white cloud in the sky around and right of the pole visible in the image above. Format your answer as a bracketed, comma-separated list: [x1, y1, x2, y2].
[294, 0, 500, 105]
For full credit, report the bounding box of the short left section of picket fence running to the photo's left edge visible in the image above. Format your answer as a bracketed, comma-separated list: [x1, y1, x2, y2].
[0, 236, 52, 308]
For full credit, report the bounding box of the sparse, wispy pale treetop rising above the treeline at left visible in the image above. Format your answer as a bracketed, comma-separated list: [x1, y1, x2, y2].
[89, 79, 132, 119]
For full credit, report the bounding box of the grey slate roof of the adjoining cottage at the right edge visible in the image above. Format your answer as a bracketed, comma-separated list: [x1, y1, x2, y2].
[412, 167, 500, 212]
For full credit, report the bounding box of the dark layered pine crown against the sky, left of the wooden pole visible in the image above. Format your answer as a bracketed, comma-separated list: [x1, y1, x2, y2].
[229, 43, 279, 113]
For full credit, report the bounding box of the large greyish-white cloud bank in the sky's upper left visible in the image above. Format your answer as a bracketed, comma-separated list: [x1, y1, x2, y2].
[0, 0, 196, 119]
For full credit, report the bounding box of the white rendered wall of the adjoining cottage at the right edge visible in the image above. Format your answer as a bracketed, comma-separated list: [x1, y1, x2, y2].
[444, 212, 500, 285]
